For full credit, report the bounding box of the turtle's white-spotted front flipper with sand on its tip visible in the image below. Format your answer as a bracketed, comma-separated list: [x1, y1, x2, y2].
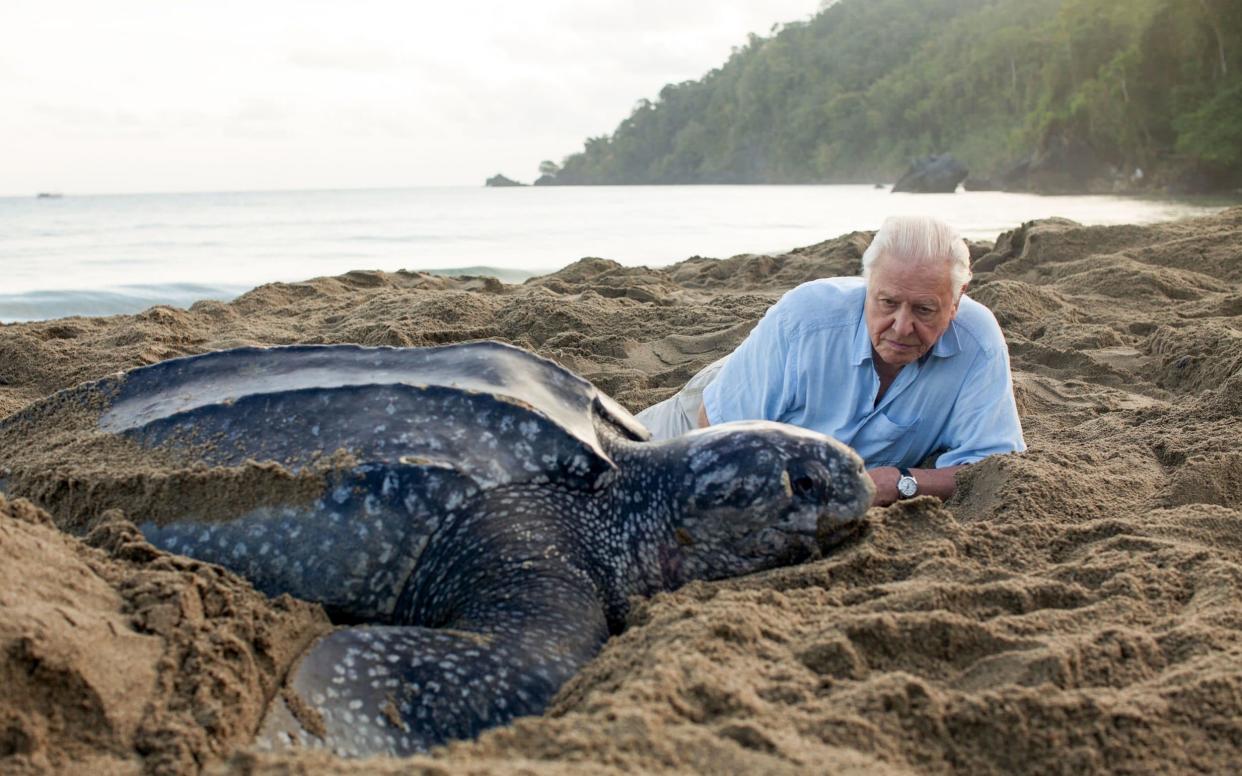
[256, 570, 607, 756]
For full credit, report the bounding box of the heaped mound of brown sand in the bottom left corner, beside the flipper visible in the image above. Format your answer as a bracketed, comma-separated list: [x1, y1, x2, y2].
[0, 495, 329, 774]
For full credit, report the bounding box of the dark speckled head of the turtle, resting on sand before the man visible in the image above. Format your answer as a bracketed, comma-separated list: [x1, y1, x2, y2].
[662, 421, 874, 585]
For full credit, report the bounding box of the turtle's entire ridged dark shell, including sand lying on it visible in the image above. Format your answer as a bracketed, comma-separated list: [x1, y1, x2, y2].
[0, 343, 647, 622]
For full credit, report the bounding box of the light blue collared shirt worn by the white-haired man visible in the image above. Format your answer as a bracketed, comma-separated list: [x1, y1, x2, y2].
[703, 277, 1026, 468]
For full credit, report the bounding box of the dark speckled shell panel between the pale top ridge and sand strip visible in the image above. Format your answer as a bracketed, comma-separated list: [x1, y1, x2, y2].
[122, 384, 617, 488]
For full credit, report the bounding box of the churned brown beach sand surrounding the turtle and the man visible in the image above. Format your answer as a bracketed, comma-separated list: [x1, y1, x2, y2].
[0, 209, 1242, 774]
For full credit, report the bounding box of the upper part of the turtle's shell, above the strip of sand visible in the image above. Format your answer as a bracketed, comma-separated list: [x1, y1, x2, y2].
[14, 341, 648, 489]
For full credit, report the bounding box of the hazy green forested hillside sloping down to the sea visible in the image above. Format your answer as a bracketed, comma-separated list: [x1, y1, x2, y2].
[539, 0, 1242, 190]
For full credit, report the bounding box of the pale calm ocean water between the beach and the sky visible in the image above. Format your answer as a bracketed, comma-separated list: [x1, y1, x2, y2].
[0, 185, 1231, 323]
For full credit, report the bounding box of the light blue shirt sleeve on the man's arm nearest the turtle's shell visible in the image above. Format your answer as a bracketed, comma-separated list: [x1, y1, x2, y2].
[703, 298, 797, 423]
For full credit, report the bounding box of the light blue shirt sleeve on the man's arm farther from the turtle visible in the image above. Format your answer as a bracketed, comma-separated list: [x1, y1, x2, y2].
[936, 338, 1026, 468]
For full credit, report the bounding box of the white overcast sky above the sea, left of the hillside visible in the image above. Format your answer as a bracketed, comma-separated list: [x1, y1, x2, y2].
[0, 0, 818, 196]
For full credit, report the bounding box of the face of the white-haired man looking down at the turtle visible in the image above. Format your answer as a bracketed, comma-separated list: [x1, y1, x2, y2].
[863, 256, 958, 366]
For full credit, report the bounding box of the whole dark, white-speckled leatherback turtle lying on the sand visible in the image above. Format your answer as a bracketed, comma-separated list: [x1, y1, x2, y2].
[0, 343, 873, 756]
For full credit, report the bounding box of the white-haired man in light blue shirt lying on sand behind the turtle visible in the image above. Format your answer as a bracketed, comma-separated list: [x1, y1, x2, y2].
[638, 216, 1026, 505]
